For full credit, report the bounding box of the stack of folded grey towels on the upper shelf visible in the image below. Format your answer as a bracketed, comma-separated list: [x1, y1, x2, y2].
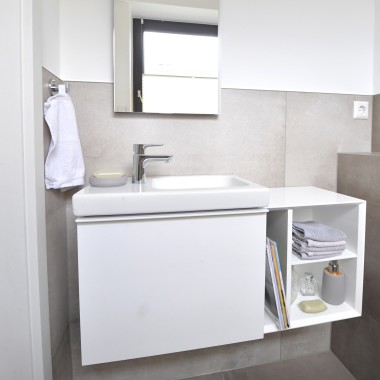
[292, 221, 346, 260]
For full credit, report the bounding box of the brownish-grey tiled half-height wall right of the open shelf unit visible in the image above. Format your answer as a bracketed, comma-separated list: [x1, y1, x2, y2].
[331, 153, 380, 380]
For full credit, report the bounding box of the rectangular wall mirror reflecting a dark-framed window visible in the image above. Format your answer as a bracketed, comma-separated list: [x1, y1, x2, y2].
[114, 0, 219, 115]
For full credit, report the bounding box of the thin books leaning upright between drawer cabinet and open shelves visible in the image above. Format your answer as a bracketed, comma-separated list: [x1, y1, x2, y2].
[265, 238, 289, 330]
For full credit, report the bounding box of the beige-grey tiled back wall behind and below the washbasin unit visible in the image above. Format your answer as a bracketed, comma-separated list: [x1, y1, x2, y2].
[43, 76, 371, 380]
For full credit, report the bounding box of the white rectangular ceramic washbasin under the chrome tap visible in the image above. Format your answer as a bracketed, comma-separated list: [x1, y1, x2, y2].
[73, 175, 269, 216]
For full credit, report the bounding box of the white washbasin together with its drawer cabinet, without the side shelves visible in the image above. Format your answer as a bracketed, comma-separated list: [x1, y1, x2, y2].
[73, 176, 269, 365]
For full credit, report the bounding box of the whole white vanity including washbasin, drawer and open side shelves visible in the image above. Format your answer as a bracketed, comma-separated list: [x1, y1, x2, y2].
[73, 180, 365, 365]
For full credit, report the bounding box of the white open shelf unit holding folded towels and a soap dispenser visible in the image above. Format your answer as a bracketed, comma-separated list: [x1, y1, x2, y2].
[264, 186, 366, 333]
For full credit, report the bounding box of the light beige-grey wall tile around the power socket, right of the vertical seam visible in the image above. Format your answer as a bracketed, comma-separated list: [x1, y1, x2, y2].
[285, 92, 372, 190]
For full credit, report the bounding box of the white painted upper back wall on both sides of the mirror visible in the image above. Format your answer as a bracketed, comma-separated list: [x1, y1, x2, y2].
[50, 0, 380, 94]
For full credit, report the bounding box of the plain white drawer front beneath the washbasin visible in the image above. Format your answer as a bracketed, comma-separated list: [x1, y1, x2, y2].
[78, 213, 266, 364]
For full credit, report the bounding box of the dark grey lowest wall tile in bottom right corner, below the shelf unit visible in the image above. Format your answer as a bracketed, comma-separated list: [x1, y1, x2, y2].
[331, 313, 380, 380]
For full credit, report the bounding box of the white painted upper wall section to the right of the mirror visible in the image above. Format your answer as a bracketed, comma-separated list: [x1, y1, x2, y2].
[220, 0, 374, 94]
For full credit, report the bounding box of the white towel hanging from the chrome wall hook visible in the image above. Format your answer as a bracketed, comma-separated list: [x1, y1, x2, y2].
[44, 94, 84, 189]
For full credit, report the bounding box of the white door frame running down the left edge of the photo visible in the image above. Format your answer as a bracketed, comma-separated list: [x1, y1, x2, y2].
[0, 0, 52, 380]
